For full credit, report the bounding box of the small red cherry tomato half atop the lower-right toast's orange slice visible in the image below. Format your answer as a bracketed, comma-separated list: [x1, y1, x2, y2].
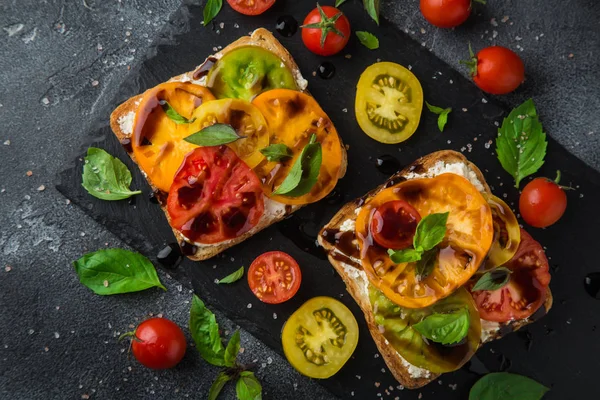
[370, 200, 421, 250]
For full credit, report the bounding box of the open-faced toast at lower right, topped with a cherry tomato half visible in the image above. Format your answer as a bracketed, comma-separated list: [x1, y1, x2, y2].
[318, 151, 552, 388]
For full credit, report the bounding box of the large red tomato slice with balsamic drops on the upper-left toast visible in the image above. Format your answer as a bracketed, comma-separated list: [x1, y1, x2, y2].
[167, 146, 264, 244]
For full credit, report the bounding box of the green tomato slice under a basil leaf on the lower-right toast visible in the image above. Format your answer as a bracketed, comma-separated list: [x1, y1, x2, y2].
[369, 285, 481, 373]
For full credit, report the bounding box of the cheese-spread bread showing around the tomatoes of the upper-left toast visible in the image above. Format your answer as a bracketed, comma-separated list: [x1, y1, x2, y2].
[110, 28, 347, 261]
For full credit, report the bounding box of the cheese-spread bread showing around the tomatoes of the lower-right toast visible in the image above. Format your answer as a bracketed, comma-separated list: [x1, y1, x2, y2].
[318, 150, 552, 389]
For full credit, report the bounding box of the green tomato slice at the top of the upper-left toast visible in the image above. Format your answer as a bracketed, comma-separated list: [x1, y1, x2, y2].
[206, 46, 298, 101]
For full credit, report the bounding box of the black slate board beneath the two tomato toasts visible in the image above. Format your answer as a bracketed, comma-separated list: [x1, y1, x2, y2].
[57, 1, 600, 399]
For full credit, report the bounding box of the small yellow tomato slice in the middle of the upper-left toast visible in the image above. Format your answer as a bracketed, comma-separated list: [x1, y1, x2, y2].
[189, 99, 269, 168]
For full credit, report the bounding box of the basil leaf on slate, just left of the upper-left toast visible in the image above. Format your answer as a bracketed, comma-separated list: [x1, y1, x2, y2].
[81, 147, 142, 200]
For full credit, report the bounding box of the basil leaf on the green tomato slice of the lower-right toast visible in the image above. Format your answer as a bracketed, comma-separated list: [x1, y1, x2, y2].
[413, 308, 472, 346]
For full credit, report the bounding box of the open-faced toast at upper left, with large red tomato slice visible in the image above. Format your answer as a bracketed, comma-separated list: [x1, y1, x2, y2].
[111, 29, 346, 260]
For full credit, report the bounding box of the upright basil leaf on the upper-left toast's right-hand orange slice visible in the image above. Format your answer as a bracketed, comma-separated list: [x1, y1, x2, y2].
[273, 134, 323, 197]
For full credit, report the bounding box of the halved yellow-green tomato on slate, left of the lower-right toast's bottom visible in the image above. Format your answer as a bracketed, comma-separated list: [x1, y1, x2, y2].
[281, 297, 358, 379]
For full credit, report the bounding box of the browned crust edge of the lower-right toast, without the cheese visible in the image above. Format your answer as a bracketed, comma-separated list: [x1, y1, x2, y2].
[317, 150, 552, 389]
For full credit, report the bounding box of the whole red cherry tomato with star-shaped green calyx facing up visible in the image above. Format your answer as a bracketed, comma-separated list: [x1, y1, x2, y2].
[302, 6, 350, 56]
